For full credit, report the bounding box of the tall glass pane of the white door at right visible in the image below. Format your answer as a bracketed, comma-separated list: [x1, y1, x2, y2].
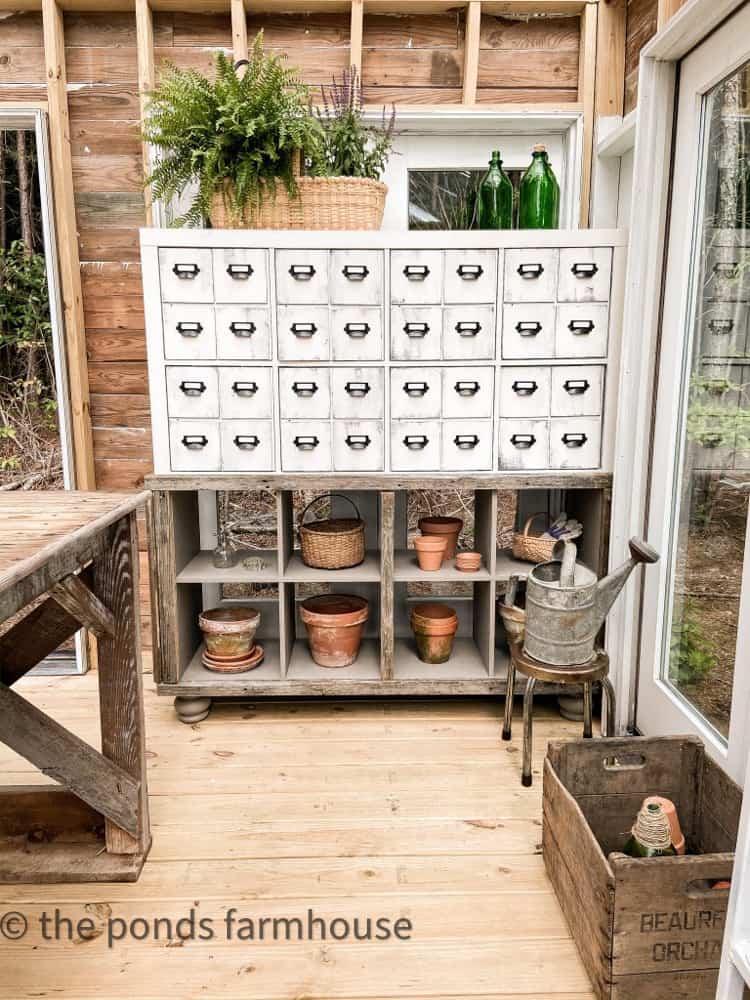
[666, 64, 750, 738]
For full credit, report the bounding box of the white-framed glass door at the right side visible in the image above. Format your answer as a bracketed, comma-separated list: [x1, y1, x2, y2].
[637, 8, 750, 773]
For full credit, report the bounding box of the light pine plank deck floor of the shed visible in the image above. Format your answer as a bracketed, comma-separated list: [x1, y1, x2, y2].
[0, 674, 593, 1000]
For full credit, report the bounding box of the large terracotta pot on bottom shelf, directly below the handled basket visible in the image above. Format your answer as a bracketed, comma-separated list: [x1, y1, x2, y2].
[300, 594, 370, 667]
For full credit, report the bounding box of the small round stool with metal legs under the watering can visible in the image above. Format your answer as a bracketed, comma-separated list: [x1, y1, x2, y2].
[503, 643, 615, 788]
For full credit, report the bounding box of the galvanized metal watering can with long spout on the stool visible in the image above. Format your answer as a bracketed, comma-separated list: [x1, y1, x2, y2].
[523, 538, 659, 666]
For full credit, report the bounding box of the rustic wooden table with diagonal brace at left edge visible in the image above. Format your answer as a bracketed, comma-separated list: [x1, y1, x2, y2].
[0, 491, 151, 882]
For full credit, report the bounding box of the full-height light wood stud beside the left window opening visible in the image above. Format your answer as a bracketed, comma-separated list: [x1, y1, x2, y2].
[42, 0, 96, 490]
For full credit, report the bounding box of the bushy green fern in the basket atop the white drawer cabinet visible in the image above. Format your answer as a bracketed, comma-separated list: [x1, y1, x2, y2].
[143, 32, 321, 225]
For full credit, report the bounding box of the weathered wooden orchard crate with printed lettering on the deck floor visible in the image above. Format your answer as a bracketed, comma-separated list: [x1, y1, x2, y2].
[543, 736, 742, 1000]
